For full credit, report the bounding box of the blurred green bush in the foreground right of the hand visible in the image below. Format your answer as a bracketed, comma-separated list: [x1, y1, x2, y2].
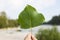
[36, 27, 60, 40]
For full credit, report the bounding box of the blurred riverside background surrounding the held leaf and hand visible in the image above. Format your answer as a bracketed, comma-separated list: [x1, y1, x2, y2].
[0, 0, 60, 40]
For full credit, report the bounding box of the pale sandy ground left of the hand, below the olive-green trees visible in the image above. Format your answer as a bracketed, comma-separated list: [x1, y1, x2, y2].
[0, 28, 27, 40]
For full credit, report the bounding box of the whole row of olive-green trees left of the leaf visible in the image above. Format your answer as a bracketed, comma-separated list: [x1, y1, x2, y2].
[0, 11, 18, 28]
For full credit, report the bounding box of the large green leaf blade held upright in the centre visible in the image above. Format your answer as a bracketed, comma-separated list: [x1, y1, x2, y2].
[18, 5, 44, 29]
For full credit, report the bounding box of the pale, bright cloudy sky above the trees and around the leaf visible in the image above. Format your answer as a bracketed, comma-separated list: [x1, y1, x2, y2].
[0, 0, 60, 21]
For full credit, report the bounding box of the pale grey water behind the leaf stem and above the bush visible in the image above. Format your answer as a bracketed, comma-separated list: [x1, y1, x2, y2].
[21, 25, 60, 34]
